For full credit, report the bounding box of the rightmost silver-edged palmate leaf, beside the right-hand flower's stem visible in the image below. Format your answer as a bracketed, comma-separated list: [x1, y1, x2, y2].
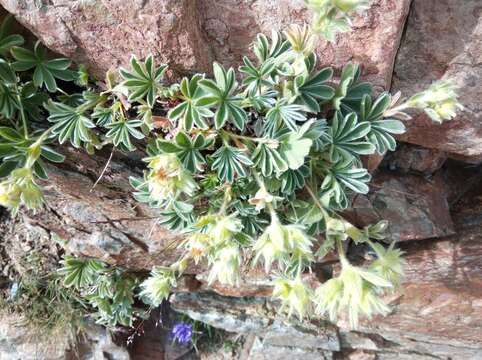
[359, 92, 405, 155]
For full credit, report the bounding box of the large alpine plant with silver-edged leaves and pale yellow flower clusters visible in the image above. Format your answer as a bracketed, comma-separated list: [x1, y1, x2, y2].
[0, 0, 461, 327]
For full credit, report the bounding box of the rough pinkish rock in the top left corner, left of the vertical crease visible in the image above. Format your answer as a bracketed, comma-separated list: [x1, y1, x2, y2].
[1, 0, 211, 79]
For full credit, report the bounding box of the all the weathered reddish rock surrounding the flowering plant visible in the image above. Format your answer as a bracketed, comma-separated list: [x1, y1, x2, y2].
[0, 0, 482, 360]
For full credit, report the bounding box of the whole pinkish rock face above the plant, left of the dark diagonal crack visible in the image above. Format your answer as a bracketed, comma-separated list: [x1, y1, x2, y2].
[0, 0, 410, 88]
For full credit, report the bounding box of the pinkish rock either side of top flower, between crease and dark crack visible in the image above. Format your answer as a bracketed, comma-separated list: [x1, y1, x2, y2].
[199, 0, 410, 89]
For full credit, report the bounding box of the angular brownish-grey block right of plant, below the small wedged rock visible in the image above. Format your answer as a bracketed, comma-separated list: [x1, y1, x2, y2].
[346, 171, 454, 241]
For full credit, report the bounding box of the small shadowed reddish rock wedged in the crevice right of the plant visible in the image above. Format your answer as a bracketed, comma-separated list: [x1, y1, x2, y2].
[387, 144, 447, 174]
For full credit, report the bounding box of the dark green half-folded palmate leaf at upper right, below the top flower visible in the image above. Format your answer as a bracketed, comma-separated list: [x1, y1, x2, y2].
[295, 68, 335, 113]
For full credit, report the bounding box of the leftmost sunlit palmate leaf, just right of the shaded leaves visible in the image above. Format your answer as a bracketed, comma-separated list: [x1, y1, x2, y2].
[45, 100, 95, 147]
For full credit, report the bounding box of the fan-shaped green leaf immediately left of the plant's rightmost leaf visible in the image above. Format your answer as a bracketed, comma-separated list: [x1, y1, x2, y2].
[328, 111, 375, 162]
